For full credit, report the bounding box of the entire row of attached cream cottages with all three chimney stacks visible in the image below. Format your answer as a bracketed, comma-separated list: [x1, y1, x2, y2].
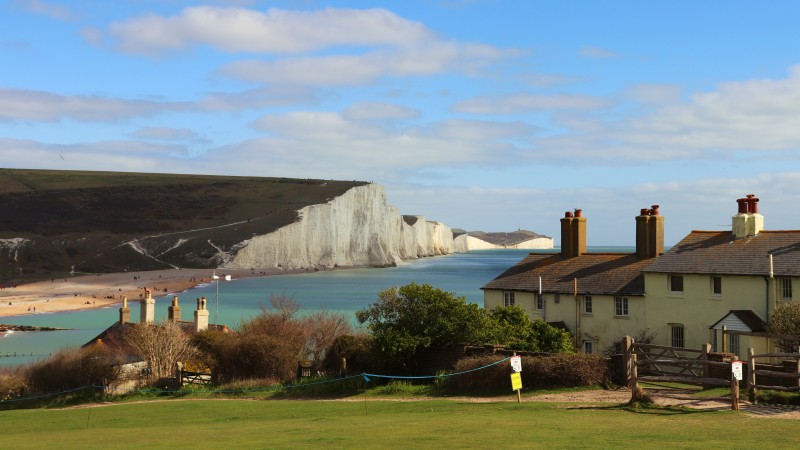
[483, 195, 800, 356]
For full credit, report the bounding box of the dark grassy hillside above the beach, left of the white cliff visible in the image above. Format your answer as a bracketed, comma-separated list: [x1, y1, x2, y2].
[0, 169, 366, 284]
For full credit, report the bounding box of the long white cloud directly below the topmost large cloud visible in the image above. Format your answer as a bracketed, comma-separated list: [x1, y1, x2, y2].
[220, 42, 517, 86]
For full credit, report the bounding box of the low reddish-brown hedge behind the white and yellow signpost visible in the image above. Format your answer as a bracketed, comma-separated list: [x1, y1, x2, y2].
[448, 353, 610, 392]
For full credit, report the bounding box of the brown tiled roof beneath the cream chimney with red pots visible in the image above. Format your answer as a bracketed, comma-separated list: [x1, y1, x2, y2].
[644, 230, 800, 276]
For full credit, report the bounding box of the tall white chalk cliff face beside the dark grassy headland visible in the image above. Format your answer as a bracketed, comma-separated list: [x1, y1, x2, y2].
[224, 184, 466, 269]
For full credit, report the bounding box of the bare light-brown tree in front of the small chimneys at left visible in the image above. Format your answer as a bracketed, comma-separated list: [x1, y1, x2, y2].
[123, 322, 197, 379]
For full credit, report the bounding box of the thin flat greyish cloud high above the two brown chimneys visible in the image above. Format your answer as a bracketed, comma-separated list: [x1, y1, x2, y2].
[453, 92, 610, 114]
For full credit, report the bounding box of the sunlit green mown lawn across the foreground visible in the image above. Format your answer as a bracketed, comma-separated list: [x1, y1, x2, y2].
[0, 399, 800, 449]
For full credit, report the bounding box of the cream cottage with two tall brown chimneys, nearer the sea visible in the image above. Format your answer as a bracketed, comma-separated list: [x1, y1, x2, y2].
[482, 205, 664, 353]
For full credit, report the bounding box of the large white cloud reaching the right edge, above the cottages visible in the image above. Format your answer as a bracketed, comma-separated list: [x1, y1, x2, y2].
[531, 66, 800, 164]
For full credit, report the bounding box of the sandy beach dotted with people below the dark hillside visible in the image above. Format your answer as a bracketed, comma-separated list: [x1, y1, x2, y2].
[0, 269, 305, 323]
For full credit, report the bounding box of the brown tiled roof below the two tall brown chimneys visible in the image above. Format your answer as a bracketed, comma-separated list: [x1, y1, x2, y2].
[482, 253, 653, 295]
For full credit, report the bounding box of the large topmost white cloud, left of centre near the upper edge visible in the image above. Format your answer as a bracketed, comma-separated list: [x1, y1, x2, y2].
[109, 6, 432, 54]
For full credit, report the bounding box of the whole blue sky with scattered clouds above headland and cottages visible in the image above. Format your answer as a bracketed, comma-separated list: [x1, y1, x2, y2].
[0, 0, 800, 246]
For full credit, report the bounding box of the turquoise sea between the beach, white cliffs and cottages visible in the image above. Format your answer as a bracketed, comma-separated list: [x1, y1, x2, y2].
[0, 247, 634, 366]
